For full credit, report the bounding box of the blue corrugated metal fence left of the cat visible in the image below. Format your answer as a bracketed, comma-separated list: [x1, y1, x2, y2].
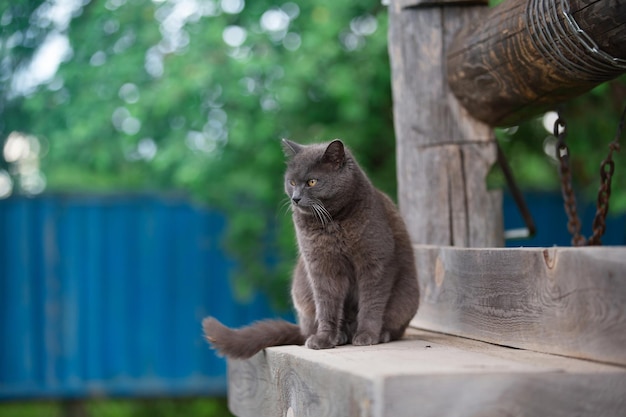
[0, 196, 275, 399]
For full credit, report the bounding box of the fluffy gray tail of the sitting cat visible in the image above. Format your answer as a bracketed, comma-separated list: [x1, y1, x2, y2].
[202, 317, 305, 359]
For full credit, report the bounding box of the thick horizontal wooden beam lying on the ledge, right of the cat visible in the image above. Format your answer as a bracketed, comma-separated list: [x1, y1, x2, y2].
[413, 246, 626, 365]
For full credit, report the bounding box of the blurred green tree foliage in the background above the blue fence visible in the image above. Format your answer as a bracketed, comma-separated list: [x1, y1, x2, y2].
[0, 0, 626, 300]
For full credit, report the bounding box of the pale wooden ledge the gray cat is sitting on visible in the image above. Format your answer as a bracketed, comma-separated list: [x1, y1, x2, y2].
[228, 330, 626, 417]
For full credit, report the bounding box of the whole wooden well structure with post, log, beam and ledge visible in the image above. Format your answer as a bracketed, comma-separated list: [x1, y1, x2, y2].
[229, 0, 626, 417]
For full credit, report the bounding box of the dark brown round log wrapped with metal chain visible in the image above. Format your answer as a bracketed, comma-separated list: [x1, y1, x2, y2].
[447, 0, 626, 126]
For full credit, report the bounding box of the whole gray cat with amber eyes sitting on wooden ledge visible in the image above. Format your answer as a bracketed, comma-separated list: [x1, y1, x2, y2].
[202, 140, 419, 359]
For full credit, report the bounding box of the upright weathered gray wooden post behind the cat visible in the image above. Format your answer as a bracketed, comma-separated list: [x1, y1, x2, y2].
[389, 0, 503, 247]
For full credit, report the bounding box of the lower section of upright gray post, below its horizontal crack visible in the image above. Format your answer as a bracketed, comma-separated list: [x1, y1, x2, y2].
[398, 143, 504, 247]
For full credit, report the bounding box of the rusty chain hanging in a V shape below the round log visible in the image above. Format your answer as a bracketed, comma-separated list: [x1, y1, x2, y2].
[554, 107, 626, 246]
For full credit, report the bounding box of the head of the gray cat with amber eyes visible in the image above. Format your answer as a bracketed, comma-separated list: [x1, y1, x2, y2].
[282, 139, 354, 223]
